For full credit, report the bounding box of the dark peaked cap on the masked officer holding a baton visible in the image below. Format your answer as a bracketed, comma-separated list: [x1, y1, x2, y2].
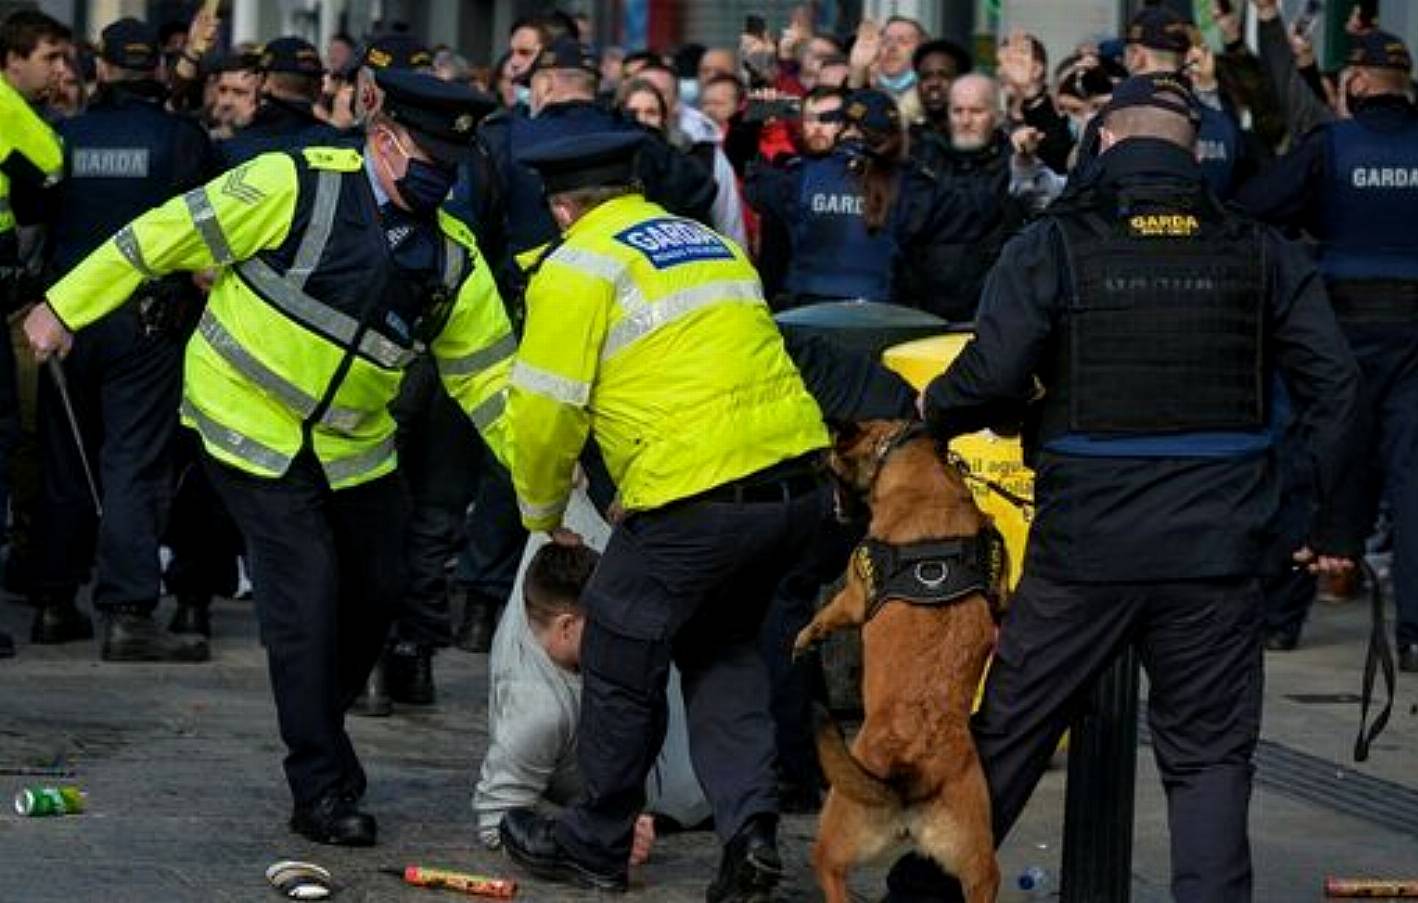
[374, 68, 498, 163]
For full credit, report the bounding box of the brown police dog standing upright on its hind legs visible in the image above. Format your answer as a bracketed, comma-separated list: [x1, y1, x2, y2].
[794, 421, 1007, 903]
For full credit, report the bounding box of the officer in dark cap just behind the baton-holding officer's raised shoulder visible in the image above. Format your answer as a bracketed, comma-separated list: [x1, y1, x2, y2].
[217, 37, 352, 169]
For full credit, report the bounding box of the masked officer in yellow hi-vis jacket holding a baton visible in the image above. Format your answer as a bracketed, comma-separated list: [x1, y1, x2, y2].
[26, 71, 515, 845]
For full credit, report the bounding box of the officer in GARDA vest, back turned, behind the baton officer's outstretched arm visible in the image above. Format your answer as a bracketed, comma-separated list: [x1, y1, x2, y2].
[33, 18, 211, 661]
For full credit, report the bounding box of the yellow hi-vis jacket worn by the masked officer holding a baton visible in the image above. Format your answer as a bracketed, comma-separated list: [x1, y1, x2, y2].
[48, 147, 516, 489]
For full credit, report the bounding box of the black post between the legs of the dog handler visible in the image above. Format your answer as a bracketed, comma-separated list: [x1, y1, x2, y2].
[1059, 644, 1140, 903]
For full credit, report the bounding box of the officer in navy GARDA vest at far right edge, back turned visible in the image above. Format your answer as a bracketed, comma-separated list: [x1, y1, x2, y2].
[1236, 31, 1418, 671]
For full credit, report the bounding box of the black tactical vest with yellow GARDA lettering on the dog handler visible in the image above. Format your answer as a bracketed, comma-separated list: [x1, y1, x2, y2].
[1041, 182, 1266, 439]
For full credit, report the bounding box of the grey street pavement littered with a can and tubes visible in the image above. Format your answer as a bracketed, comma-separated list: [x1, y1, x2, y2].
[0, 581, 1418, 903]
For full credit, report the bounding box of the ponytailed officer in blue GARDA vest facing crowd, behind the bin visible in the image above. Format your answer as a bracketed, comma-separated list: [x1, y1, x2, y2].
[744, 89, 1000, 320]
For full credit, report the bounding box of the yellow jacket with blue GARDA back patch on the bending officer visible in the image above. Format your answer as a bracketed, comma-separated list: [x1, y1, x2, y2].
[509, 194, 827, 530]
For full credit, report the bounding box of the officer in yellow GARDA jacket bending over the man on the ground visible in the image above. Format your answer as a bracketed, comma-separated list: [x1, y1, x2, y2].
[502, 133, 831, 903]
